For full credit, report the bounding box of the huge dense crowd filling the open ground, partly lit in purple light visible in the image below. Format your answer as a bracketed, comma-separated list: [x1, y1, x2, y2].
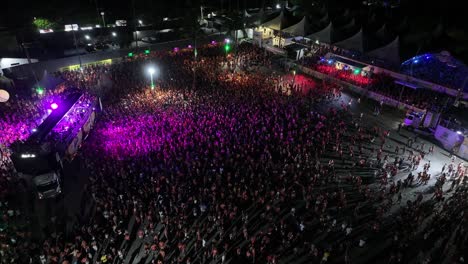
[0, 44, 468, 264]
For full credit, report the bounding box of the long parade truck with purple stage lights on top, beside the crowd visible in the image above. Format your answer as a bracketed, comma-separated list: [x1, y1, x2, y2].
[10, 92, 97, 199]
